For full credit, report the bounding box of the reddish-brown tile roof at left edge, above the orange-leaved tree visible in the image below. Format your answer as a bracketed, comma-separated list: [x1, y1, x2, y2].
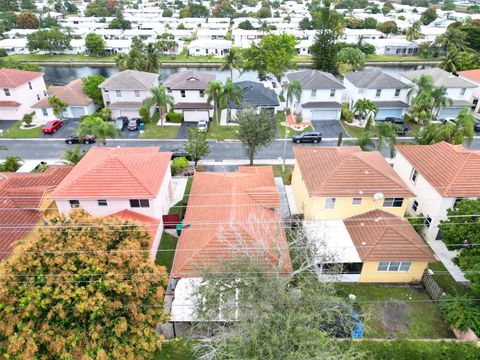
[0, 166, 72, 260]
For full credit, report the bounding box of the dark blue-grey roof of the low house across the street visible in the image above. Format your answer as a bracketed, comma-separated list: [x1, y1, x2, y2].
[228, 81, 280, 109]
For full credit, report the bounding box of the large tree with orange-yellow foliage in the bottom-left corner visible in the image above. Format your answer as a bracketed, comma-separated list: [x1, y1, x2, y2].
[0, 211, 168, 359]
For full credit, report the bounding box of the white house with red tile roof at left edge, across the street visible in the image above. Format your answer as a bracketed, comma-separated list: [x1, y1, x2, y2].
[0, 69, 47, 120]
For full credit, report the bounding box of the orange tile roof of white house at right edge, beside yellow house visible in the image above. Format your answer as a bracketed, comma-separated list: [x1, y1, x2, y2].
[397, 142, 480, 197]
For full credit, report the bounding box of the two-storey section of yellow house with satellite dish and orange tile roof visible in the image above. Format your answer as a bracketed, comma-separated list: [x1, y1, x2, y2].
[292, 146, 415, 220]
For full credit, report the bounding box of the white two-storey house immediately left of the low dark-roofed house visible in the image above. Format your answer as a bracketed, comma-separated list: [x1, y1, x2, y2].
[164, 70, 215, 122]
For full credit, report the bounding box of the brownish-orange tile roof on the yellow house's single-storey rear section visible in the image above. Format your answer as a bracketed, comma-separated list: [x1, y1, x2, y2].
[344, 210, 435, 261]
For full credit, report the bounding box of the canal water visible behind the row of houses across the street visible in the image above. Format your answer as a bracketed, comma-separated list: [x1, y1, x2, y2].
[43, 65, 432, 85]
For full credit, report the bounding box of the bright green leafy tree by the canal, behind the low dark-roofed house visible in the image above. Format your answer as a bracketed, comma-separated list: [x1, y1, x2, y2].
[243, 34, 297, 83]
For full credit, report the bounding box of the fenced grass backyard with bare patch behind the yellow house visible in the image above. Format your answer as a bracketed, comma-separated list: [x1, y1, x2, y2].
[337, 284, 453, 339]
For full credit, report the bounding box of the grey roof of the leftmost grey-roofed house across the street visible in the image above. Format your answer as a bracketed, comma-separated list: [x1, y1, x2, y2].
[98, 70, 159, 90]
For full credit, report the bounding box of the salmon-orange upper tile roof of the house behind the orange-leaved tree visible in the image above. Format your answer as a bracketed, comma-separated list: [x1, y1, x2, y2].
[51, 147, 172, 199]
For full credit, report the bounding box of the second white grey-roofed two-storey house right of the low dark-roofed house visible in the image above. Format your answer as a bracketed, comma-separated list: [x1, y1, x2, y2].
[343, 69, 409, 120]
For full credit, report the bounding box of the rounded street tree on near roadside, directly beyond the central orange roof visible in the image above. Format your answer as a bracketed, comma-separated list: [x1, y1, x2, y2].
[237, 109, 277, 165]
